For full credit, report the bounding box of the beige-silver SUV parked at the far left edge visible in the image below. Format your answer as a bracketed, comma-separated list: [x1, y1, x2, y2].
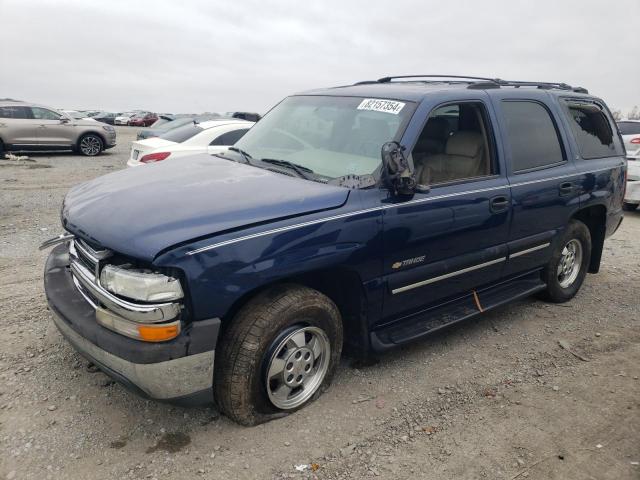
[0, 101, 116, 157]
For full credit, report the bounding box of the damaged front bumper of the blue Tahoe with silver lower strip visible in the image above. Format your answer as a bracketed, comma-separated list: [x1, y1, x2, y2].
[44, 244, 220, 405]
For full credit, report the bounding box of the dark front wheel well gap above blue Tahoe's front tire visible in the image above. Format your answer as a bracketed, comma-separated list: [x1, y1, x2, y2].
[222, 267, 369, 356]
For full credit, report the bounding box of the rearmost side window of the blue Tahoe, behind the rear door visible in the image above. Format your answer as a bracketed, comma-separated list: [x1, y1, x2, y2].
[564, 101, 624, 159]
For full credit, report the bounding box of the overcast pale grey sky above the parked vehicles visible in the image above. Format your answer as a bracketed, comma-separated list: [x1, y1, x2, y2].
[0, 0, 640, 112]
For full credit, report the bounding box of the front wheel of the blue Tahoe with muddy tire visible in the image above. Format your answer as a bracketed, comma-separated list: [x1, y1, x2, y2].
[213, 285, 342, 425]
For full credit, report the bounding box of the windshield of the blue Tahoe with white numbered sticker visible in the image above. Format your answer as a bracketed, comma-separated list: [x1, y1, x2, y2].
[236, 96, 415, 178]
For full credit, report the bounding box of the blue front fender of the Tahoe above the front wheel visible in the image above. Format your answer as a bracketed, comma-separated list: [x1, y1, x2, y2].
[154, 195, 382, 320]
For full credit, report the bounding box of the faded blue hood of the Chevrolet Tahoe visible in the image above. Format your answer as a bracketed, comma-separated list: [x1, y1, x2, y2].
[62, 154, 349, 261]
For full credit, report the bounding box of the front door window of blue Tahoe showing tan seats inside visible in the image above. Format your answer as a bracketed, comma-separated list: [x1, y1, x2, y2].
[411, 102, 497, 185]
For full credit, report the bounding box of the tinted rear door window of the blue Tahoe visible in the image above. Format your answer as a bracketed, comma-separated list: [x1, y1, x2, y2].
[502, 101, 565, 172]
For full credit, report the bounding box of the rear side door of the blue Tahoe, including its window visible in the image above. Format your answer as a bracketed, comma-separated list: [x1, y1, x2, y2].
[491, 89, 580, 276]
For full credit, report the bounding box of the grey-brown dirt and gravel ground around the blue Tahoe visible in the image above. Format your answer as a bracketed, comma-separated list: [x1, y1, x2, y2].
[0, 127, 640, 480]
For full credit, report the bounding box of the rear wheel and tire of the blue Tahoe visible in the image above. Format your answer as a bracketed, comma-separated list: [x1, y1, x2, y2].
[542, 220, 591, 303]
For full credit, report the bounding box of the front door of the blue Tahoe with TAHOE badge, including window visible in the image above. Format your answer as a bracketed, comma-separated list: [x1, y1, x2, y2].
[381, 100, 511, 324]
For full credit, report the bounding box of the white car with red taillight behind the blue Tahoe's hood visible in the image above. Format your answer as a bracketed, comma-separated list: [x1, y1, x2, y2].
[127, 119, 254, 167]
